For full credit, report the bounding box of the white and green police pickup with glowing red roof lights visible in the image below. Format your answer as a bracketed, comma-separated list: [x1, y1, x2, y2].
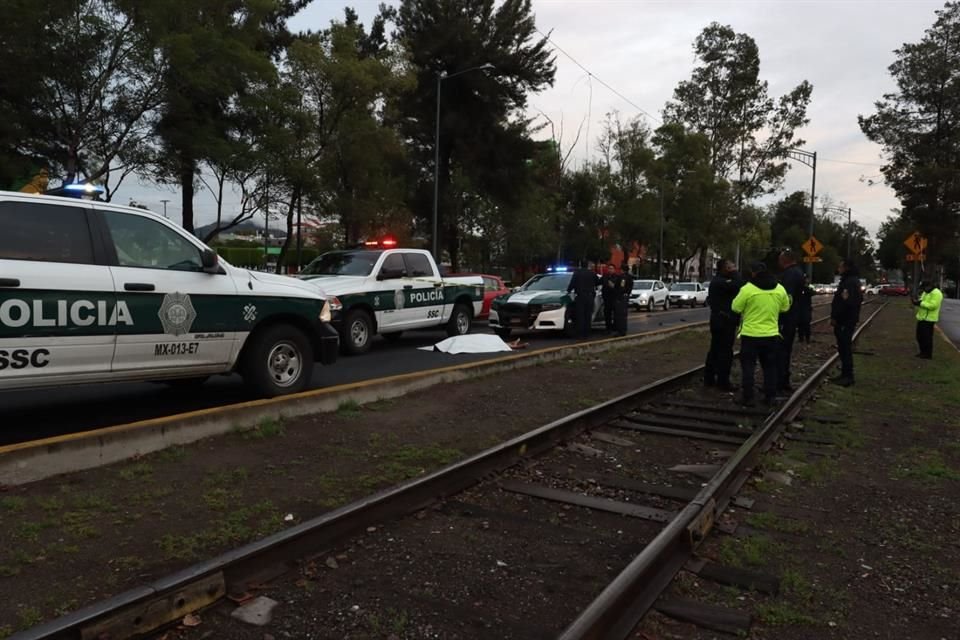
[299, 243, 483, 354]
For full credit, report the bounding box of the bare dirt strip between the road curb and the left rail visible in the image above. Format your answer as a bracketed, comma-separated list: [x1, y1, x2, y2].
[0, 324, 724, 638]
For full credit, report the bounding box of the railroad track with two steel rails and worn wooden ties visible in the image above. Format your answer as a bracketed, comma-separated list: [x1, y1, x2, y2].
[13, 302, 876, 640]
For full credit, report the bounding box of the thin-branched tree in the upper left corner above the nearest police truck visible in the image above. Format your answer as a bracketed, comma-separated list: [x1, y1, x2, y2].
[0, 0, 164, 195]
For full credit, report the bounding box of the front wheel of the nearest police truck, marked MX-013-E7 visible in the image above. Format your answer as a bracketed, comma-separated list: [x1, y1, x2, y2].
[240, 324, 313, 398]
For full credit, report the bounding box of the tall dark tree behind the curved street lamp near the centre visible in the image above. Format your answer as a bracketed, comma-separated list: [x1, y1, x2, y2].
[395, 0, 555, 269]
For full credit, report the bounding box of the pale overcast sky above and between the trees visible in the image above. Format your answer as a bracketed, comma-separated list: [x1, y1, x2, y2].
[116, 0, 944, 240]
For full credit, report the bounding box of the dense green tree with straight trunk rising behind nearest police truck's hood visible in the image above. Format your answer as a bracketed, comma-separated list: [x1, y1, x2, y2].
[135, 0, 308, 231]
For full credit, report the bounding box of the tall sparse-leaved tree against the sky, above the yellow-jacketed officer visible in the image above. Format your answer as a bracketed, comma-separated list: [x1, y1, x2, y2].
[664, 22, 813, 276]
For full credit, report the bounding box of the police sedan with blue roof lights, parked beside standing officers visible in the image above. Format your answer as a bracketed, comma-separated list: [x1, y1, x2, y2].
[490, 272, 603, 339]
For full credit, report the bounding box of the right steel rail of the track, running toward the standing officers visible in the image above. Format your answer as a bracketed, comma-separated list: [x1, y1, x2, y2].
[558, 304, 886, 640]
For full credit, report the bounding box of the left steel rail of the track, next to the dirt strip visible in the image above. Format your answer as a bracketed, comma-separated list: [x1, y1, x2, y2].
[9, 306, 848, 640]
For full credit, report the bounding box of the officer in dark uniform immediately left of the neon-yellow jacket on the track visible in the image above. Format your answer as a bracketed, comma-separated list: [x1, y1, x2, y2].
[703, 259, 743, 391]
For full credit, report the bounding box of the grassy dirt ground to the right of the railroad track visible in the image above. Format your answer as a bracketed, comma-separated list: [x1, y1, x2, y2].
[637, 301, 960, 640]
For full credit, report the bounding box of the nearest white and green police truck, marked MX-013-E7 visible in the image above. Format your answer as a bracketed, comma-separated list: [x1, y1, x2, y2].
[0, 191, 338, 396]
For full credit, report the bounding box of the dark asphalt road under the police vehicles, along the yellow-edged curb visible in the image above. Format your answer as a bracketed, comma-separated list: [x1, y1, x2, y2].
[0, 308, 709, 445]
